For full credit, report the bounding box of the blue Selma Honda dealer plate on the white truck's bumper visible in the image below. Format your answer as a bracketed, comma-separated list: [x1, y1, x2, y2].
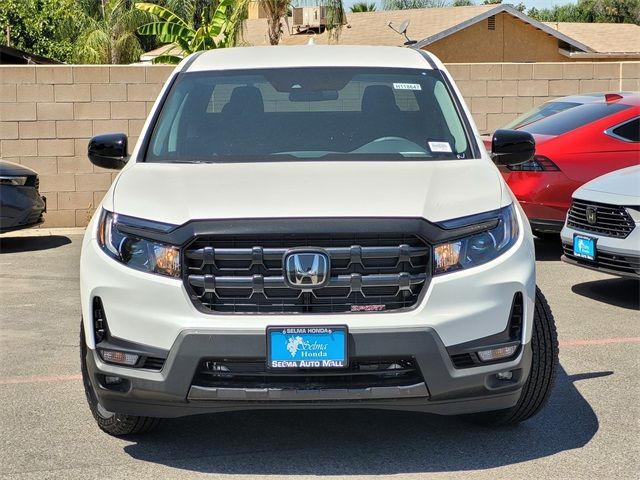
[267, 326, 349, 369]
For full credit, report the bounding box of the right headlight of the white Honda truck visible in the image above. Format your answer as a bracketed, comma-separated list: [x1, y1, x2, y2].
[433, 204, 518, 275]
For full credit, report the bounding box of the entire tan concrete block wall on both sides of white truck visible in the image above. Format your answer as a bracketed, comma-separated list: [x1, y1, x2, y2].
[0, 62, 640, 227]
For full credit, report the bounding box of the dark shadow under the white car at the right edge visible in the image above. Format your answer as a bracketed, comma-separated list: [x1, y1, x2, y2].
[571, 278, 640, 310]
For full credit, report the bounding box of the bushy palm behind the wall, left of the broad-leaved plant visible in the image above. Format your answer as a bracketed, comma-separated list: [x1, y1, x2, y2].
[74, 0, 148, 64]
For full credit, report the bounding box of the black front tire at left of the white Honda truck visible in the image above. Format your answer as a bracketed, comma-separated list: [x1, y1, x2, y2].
[80, 323, 160, 436]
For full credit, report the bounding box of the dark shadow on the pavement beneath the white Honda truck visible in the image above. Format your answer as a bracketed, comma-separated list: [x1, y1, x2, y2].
[124, 368, 613, 476]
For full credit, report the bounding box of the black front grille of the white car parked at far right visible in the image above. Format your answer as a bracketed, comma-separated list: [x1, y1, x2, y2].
[567, 199, 635, 238]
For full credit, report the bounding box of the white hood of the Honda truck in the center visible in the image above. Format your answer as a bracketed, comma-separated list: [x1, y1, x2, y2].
[113, 160, 511, 225]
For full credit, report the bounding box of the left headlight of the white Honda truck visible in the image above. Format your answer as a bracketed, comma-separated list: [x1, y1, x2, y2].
[98, 210, 180, 277]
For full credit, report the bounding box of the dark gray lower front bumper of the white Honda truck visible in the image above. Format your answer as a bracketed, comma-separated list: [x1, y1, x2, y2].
[86, 327, 531, 417]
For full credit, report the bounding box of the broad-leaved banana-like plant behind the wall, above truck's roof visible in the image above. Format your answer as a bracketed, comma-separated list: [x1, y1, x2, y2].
[135, 0, 235, 64]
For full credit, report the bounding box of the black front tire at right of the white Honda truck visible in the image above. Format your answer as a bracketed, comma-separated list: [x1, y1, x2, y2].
[466, 287, 558, 425]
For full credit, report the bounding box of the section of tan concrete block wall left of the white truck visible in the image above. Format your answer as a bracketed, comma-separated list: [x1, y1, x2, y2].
[0, 65, 173, 227]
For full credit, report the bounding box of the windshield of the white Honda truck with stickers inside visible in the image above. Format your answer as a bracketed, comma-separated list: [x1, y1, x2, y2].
[146, 68, 473, 162]
